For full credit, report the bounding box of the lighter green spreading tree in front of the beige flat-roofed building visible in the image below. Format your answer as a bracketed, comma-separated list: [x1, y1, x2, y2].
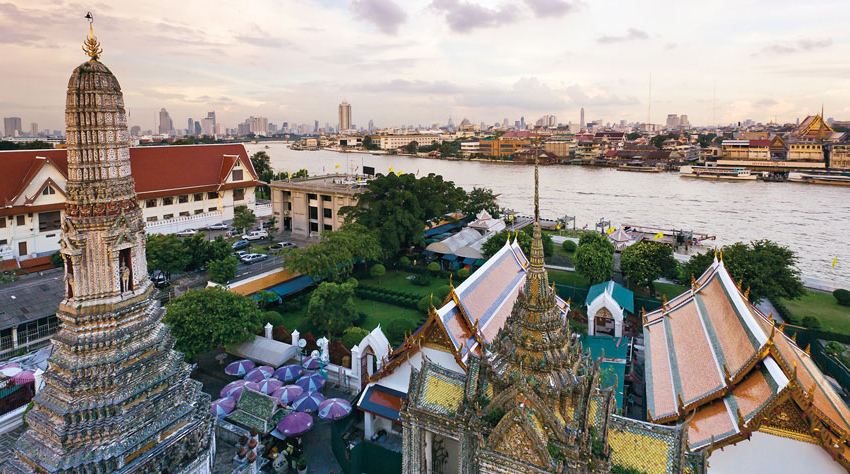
[283, 222, 381, 282]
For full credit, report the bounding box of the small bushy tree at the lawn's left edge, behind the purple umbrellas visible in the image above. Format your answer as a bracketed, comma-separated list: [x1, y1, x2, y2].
[307, 282, 357, 336]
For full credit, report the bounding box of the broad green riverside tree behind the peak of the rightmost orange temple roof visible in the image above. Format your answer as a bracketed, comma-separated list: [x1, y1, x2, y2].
[683, 240, 804, 303]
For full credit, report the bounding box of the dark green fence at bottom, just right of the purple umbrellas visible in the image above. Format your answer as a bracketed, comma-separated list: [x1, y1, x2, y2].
[331, 416, 401, 474]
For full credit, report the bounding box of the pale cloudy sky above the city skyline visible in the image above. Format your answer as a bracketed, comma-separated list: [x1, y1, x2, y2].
[0, 0, 850, 129]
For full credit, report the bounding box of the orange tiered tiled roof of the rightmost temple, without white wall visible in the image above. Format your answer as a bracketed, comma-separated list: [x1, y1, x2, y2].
[644, 261, 850, 462]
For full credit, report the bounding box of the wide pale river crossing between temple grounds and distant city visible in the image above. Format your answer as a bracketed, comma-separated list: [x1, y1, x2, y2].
[246, 143, 850, 282]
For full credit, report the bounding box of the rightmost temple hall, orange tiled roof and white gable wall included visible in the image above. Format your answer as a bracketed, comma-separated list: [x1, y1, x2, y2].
[643, 255, 850, 473]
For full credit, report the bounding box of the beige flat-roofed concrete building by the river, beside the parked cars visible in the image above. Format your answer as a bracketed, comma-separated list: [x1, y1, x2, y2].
[269, 174, 367, 237]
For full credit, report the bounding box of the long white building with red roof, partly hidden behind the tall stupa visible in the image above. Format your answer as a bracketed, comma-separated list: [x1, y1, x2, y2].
[0, 144, 259, 264]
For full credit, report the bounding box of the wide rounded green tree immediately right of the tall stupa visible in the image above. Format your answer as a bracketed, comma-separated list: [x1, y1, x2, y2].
[164, 287, 262, 359]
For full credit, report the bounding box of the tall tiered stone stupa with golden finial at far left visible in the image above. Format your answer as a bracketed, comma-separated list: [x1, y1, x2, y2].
[3, 16, 214, 473]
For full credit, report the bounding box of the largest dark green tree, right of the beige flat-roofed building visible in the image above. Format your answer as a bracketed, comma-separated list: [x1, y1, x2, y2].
[340, 173, 466, 255]
